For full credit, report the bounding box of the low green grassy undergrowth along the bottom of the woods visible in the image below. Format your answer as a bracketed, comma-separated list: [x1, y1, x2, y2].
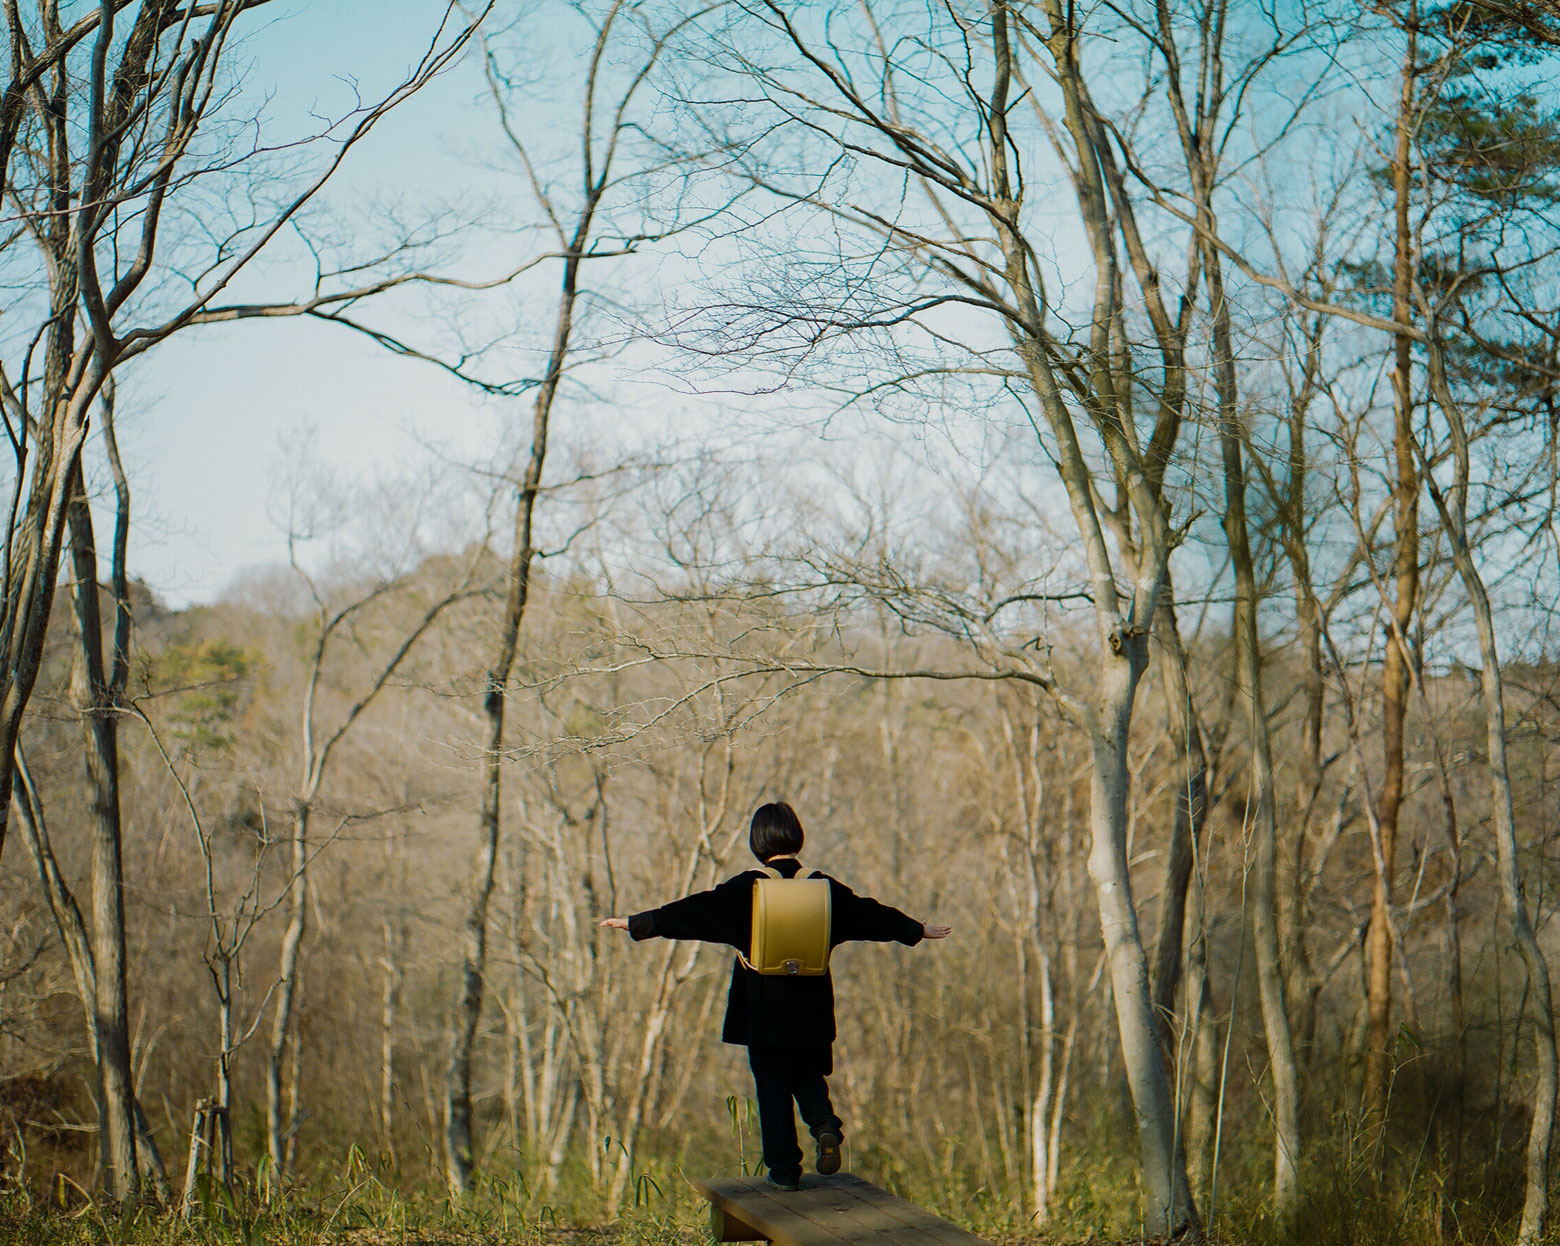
[0, 1143, 1560, 1246]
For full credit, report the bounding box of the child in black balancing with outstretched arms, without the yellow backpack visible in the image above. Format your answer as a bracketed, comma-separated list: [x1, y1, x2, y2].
[601, 802, 950, 1190]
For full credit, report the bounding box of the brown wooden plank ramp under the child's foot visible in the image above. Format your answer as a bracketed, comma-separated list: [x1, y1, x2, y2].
[691, 1173, 986, 1246]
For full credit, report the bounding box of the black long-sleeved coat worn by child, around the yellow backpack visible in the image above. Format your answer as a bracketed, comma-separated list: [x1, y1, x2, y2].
[629, 861, 922, 1048]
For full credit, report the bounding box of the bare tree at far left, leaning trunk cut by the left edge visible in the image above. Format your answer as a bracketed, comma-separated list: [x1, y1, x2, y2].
[0, 0, 470, 892]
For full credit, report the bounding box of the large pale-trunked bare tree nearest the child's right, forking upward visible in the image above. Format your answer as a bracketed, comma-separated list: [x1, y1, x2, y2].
[683, 3, 1229, 1232]
